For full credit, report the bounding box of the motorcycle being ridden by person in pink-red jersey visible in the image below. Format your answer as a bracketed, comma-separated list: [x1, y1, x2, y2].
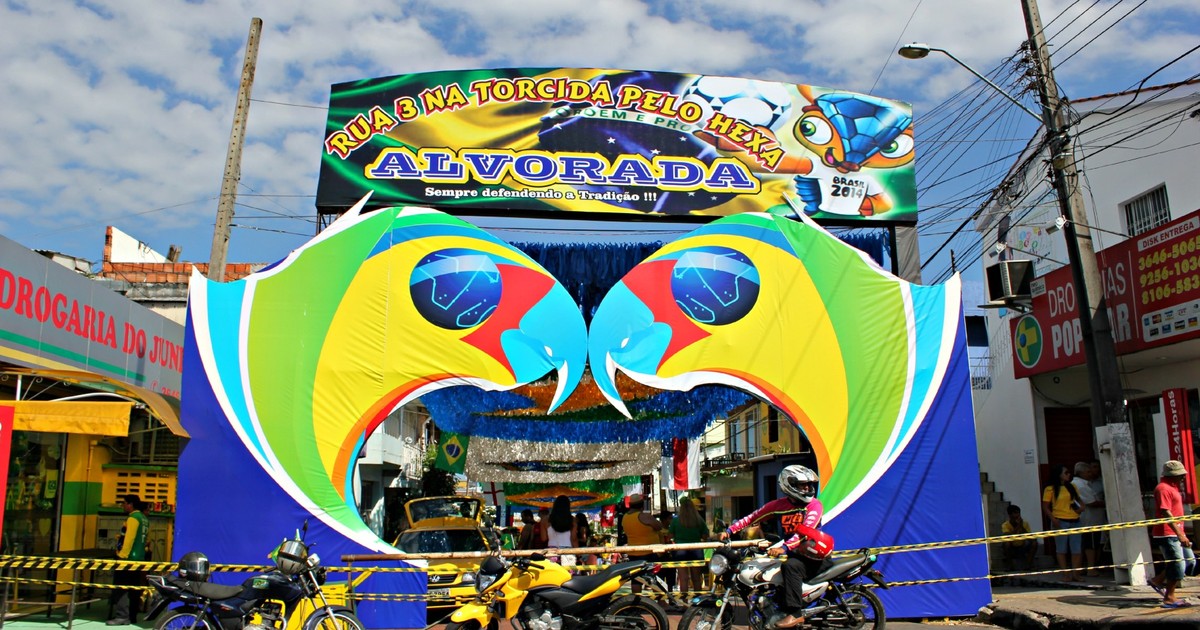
[678, 546, 887, 630]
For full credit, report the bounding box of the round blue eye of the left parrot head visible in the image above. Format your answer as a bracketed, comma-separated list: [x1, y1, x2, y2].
[408, 248, 504, 330]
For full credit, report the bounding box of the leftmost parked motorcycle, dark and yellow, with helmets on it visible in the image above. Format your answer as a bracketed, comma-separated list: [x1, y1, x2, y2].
[145, 523, 365, 630]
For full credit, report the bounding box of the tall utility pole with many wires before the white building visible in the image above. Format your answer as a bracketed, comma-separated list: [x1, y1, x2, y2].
[1021, 0, 1151, 584]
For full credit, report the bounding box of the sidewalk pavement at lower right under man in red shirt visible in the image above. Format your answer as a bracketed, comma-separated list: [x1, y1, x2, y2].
[977, 575, 1200, 630]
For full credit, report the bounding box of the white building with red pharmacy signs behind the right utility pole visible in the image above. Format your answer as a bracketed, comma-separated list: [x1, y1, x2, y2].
[968, 82, 1200, 533]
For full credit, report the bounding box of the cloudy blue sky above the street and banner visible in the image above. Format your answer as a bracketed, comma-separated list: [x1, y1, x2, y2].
[0, 0, 1200, 273]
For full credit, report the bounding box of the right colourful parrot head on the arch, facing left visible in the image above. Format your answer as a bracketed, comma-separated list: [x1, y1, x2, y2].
[588, 214, 961, 518]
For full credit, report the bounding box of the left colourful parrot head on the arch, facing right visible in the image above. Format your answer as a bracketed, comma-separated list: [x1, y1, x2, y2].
[190, 199, 587, 550]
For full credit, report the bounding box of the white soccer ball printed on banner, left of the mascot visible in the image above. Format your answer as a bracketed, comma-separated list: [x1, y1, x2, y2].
[683, 77, 792, 131]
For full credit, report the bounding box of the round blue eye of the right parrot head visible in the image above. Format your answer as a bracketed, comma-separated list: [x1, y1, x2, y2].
[671, 246, 760, 326]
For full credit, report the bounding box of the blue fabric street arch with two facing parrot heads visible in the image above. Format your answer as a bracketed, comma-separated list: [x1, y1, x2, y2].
[176, 204, 990, 626]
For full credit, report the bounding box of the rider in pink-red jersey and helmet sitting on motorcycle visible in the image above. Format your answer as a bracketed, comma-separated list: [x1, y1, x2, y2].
[721, 464, 833, 628]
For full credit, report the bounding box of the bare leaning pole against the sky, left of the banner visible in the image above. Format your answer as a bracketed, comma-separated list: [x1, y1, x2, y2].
[209, 18, 263, 282]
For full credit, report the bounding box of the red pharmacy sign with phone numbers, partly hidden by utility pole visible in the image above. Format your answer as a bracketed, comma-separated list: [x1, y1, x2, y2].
[1009, 211, 1200, 378]
